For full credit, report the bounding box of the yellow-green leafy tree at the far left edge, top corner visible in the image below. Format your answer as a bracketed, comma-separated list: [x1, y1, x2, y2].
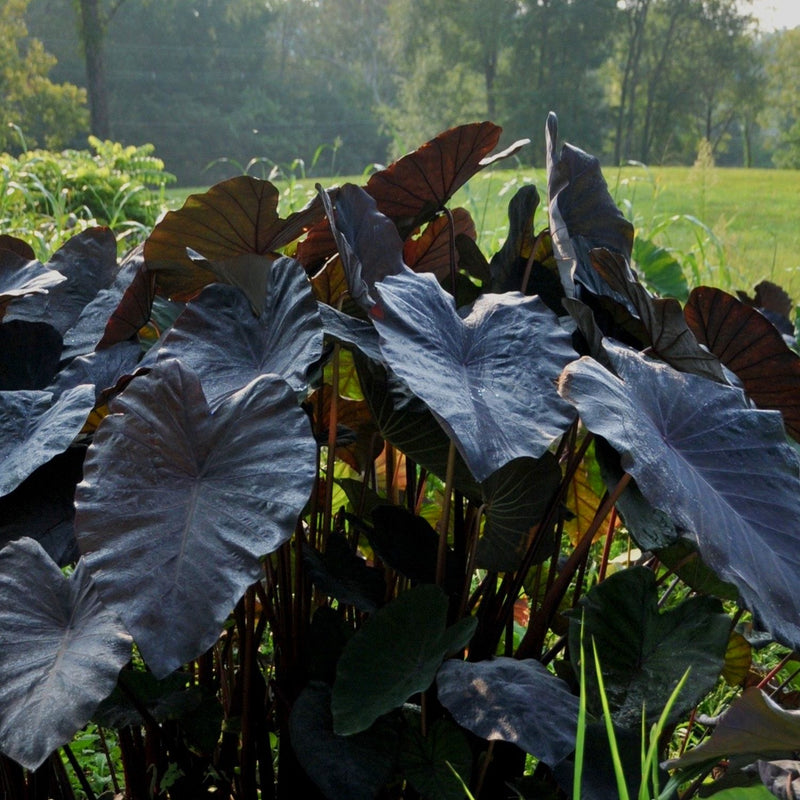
[0, 0, 87, 153]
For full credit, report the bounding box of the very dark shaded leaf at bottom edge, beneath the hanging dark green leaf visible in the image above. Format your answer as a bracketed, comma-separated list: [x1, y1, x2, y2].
[289, 683, 398, 800]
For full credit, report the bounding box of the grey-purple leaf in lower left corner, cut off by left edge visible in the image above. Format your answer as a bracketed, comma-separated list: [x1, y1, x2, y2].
[0, 539, 131, 769]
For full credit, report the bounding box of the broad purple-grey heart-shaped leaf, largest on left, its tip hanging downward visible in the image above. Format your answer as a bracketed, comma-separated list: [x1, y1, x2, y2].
[75, 361, 316, 677]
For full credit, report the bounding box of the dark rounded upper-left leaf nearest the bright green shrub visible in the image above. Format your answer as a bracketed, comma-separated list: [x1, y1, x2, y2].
[7, 228, 117, 335]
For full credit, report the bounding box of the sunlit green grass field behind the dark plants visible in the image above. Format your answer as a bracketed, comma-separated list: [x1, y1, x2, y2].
[169, 166, 800, 304]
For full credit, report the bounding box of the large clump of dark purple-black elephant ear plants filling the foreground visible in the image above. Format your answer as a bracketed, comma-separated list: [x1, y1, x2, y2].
[0, 116, 800, 800]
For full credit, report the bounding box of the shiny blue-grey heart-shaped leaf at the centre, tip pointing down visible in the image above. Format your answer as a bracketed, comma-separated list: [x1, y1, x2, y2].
[372, 271, 574, 481]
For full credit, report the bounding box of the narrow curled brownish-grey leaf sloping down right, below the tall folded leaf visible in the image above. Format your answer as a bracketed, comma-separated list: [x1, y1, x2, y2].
[589, 248, 725, 382]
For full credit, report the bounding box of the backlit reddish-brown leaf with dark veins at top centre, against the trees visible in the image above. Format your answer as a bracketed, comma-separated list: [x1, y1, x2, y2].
[366, 122, 502, 238]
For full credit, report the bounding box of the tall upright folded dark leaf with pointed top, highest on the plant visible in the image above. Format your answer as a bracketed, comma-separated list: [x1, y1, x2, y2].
[546, 112, 633, 297]
